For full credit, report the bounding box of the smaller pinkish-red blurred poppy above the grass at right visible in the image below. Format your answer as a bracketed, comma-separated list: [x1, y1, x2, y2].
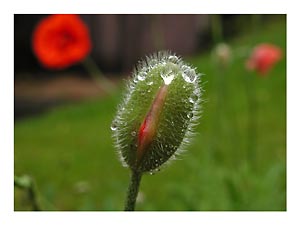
[246, 44, 282, 75]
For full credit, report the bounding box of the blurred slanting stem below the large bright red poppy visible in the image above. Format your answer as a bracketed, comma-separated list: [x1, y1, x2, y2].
[82, 56, 115, 93]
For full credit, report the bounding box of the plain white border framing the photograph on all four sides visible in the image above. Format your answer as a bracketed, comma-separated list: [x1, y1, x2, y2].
[0, 0, 300, 225]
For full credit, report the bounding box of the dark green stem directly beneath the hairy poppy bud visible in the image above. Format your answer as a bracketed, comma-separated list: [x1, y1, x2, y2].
[124, 170, 142, 211]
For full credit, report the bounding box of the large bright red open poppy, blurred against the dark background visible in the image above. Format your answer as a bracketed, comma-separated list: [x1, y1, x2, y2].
[32, 14, 91, 69]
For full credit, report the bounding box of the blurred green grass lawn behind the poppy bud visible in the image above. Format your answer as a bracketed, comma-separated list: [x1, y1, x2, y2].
[14, 18, 286, 211]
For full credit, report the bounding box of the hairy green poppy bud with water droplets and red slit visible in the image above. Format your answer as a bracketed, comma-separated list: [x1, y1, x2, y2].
[111, 51, 202, 173]
